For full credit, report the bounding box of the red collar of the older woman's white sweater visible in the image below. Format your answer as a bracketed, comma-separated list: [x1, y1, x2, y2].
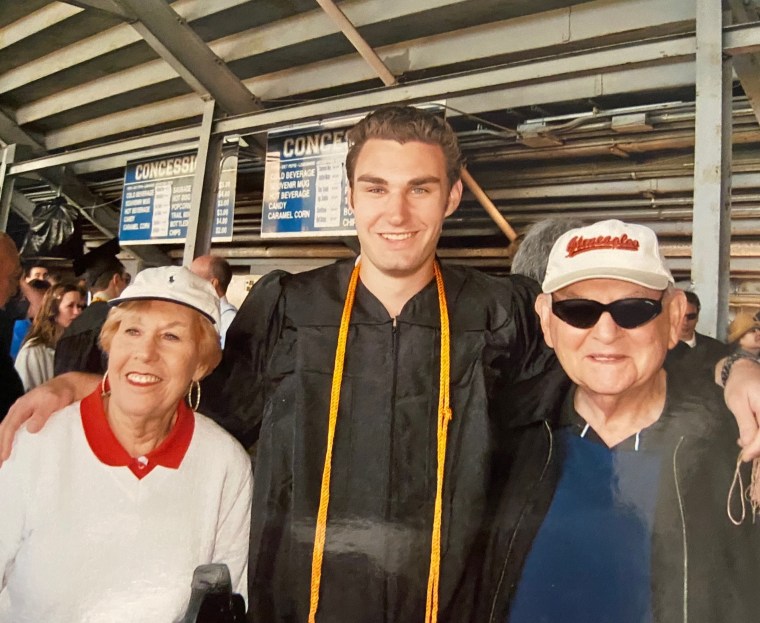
[80, 386, 195, 479]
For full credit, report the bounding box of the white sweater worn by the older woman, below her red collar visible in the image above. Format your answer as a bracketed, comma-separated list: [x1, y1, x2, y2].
[0, 403, 252, 623]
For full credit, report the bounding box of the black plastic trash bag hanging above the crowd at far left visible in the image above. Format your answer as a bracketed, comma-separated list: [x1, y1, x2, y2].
[21, 197, 83, 259]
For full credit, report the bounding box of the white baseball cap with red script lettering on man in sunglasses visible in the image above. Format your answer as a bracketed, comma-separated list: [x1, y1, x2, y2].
[542, 219, 674, 293]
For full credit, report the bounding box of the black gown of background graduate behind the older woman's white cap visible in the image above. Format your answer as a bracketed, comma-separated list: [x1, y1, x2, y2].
[54, 301, 110, 376]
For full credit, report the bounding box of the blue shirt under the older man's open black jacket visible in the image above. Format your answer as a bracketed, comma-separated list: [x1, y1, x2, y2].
[509, 426, 660, 623]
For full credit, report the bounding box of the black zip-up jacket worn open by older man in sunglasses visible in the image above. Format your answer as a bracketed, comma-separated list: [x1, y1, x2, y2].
[453, 375, 760, 623]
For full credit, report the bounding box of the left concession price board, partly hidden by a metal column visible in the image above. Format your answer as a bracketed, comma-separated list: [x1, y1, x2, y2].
[119, 151, 237, 246]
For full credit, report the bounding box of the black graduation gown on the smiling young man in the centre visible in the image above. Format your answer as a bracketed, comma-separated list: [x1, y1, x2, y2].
[201, 261, 553, 623]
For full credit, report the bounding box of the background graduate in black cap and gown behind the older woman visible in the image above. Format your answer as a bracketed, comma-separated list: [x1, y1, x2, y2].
[54, 255, 128, 376]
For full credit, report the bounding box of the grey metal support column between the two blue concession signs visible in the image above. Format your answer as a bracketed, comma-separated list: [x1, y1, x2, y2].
[182, 99, 224, 266]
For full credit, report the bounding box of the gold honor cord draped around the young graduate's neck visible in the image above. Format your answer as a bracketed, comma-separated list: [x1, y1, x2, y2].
[309, 262, 451, 623]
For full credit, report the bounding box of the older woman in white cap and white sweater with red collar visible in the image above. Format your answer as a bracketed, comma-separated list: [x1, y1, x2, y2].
[0, 267, 251, 623]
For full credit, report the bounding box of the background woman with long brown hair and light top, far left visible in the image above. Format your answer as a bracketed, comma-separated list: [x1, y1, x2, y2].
[15, 284, 85, 391]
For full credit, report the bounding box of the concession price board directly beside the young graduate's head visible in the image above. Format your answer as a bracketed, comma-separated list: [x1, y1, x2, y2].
[261, 124, 356, 238]
